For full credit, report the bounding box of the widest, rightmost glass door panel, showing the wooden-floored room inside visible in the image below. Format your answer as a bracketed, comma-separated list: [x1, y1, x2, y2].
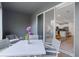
[55, 3, 75, 56]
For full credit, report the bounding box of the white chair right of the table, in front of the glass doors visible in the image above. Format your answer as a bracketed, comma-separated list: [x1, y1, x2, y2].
[45, 39, 61, 57]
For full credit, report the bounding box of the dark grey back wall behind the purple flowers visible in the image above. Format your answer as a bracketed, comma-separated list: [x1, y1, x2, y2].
[3, 9, 30, 37]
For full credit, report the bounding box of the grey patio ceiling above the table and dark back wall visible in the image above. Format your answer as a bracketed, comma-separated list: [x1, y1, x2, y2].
[2, 2, 59, 15]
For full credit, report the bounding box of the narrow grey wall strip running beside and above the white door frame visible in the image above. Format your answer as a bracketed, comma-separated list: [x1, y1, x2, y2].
[31, 2, 60, 34]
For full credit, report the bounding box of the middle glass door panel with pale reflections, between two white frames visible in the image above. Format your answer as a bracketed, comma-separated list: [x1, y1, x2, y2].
[45, 10, 55, 43]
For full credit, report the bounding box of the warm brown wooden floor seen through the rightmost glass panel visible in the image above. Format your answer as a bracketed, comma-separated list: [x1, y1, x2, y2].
[60, 37, 74, 56]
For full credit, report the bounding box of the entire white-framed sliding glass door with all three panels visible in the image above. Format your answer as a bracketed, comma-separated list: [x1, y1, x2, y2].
[37, 3, 75, 56]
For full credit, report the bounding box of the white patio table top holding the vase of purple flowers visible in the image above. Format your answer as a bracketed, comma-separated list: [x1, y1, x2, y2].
[0, 40, 46, 57]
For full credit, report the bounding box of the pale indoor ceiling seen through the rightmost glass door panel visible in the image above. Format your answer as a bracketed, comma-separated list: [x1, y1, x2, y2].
[56, 4, 74, 23]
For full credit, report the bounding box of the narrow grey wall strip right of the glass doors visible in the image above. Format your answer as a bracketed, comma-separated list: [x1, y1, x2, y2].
[75, 2, 79, 57]
